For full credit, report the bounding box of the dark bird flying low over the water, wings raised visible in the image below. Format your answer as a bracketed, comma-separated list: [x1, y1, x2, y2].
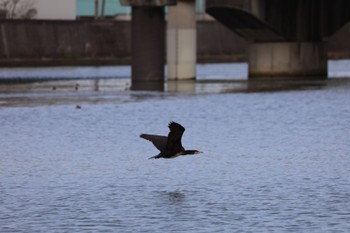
[140, 122, 203, 159]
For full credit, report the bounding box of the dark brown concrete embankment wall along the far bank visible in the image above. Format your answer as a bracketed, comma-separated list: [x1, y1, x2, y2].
[0, 20, 350, 67]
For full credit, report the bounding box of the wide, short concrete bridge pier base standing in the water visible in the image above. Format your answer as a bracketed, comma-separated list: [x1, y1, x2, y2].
[248, 42, 327, 78]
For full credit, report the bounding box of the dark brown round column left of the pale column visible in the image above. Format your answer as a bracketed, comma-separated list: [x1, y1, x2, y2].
[131, 6, 165, 87]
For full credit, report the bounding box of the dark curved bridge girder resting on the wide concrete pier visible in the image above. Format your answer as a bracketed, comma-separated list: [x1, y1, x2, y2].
[206, 0, 350, 42]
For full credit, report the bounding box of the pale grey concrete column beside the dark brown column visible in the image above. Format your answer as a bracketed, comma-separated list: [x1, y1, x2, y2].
[167, 0, 197, 79]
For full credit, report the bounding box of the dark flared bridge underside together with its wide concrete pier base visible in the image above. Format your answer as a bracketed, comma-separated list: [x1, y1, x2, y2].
[206, 0, 350, 78]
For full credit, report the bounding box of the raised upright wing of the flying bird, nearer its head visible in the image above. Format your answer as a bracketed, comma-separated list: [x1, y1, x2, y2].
[166, 121, 185, 153]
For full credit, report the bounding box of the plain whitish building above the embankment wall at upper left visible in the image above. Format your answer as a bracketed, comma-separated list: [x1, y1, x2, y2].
[30, 0, 76, 20]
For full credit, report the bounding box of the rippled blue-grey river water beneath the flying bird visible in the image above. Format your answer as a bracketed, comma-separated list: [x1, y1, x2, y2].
[0, 61, 350, 233]
